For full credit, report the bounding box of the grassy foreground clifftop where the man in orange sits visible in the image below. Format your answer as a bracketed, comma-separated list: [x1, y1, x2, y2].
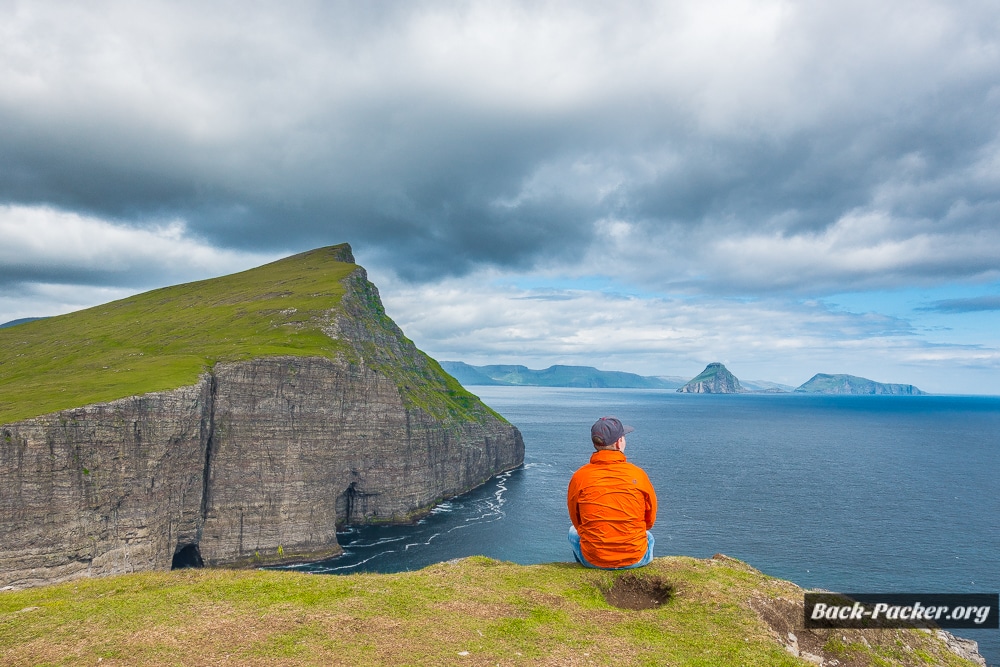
[0, 557, 970, 667]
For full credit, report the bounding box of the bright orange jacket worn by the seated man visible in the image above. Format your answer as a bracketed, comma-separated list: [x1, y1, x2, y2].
[566, 449, 656, 567]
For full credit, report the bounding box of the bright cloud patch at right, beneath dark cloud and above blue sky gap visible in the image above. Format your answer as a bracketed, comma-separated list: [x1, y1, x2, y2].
[580, 204, 1000, 296]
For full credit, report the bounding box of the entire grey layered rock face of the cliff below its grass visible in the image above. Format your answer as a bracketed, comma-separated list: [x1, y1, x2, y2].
[0, 358, 524, 587]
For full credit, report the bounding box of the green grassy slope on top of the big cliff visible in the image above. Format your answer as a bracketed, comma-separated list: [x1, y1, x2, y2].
[0, 246, 357, 424]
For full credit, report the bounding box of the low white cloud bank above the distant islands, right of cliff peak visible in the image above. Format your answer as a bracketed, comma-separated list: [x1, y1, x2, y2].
[380, 268, 936, 382]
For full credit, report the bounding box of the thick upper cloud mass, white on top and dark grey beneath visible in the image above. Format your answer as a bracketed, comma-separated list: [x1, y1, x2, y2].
[0, 2, 1000, 293]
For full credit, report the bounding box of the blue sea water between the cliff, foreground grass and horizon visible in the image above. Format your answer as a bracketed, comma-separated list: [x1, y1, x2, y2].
[286, 387, 1000, 665]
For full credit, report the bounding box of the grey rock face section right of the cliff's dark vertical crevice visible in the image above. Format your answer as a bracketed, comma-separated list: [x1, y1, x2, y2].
[200, 358, 524, 565]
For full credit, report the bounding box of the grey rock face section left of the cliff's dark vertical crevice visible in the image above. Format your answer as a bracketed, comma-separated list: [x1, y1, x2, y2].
[0, 378, 212, 587]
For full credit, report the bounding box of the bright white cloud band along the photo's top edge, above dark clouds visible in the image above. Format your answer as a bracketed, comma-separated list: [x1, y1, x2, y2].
[0, 0, 996, 146]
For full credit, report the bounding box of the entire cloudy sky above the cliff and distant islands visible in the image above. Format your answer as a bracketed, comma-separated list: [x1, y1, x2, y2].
[0, 0, 1000, 394]
